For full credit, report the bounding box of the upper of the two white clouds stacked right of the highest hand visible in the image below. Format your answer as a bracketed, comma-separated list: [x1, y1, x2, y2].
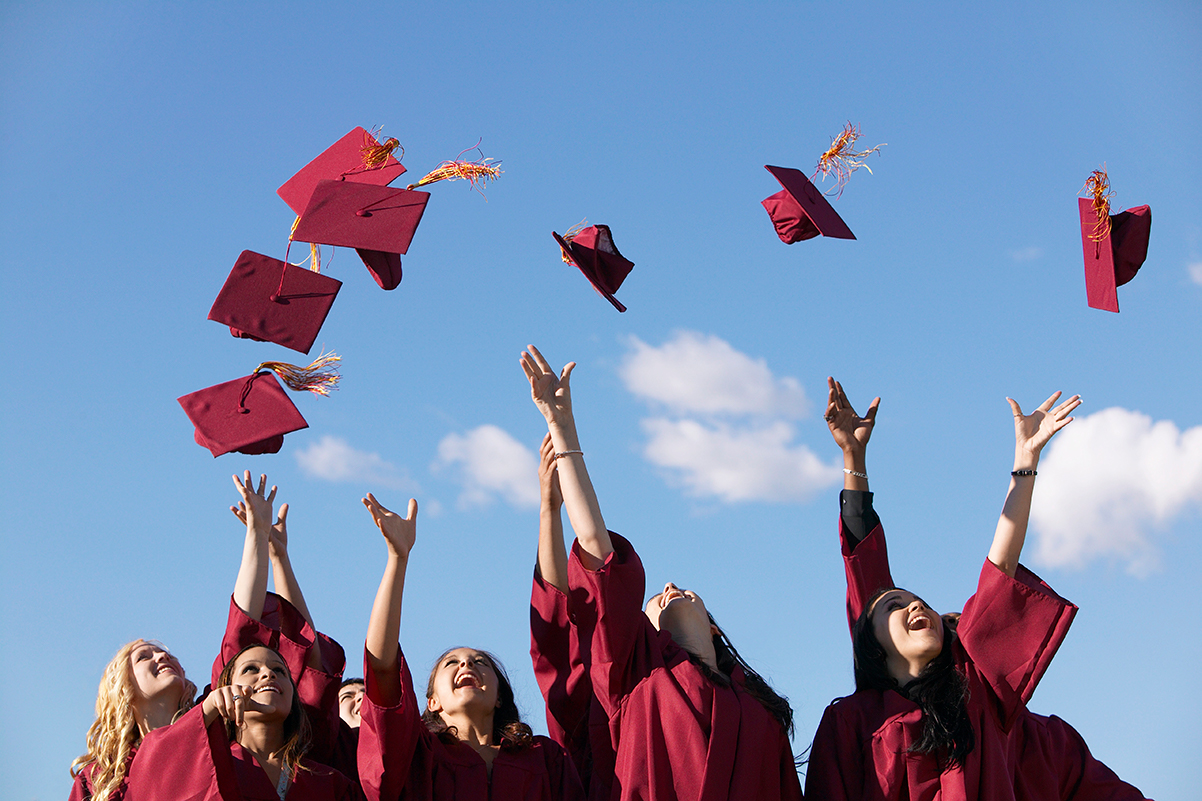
[619, 331, 808, 417]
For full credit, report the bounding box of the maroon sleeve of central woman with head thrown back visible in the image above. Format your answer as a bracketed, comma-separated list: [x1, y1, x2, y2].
[567, 532, 664, 718]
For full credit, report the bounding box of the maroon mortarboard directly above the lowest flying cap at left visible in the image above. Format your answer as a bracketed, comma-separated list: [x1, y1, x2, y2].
[209, 250, 343, 354]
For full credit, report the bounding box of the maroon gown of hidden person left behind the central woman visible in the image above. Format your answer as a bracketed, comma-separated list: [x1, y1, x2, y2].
[530, 570, 614, 801]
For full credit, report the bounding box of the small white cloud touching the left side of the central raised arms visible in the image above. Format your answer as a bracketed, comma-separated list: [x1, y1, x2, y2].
[434, 426, 538, 508]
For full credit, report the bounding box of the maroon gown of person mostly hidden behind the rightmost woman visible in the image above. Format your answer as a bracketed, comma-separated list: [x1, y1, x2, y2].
[836, 505, 1144, 801]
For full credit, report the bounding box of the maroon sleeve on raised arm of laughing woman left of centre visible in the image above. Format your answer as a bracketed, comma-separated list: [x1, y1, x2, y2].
[357, 646, 429, 801]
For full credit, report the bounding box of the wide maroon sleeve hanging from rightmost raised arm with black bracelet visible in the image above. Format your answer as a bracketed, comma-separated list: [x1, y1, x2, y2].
[957, 559, 1077, 726]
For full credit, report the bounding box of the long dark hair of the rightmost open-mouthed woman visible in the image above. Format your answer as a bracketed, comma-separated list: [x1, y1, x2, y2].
[851, 588, 976, 770]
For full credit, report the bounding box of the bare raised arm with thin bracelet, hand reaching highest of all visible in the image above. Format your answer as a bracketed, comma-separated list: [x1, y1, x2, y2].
[522, 345, 613, 570]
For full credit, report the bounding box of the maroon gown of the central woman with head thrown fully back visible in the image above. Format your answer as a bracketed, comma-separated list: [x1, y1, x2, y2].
[569, 533, 802, 801]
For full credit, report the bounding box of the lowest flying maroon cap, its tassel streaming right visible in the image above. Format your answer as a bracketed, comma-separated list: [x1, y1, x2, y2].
[179, 354, 340, 457]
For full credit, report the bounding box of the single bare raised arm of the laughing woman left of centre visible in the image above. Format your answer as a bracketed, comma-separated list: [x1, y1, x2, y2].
[363, 493, 417, 706]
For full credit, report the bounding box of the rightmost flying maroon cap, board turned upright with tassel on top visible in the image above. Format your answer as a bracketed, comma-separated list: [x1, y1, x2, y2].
[1077, 170, 1152, 313]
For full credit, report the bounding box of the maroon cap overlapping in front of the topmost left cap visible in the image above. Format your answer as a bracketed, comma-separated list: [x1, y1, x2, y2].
[292, 180, 430, 290]
